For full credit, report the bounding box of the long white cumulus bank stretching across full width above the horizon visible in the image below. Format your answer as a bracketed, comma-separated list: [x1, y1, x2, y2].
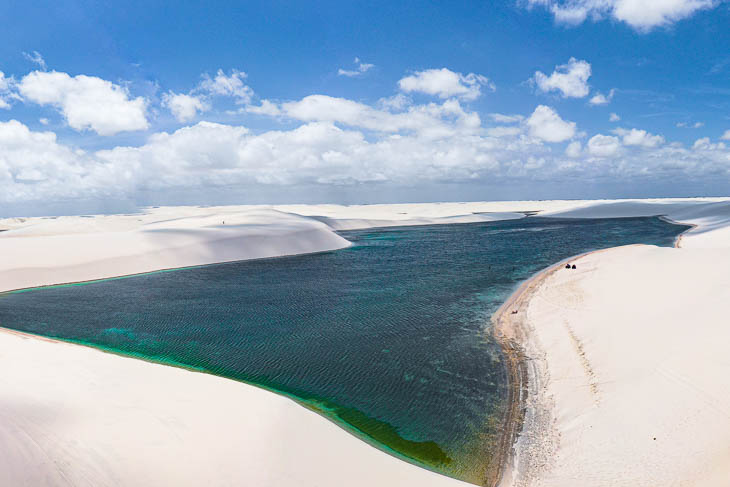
[0, 76, 730, 208]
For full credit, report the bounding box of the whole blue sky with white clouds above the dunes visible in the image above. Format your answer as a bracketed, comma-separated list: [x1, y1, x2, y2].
[0, 0, 730, 216]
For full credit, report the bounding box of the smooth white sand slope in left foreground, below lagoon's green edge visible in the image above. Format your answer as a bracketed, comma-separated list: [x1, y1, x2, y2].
[0, 332, 467, 487]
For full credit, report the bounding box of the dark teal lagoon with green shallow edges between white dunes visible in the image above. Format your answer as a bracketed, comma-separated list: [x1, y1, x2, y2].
[0, 218, 686, 483]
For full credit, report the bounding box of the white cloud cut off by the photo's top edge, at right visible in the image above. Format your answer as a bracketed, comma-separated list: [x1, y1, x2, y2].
[527, 0, 721, 32]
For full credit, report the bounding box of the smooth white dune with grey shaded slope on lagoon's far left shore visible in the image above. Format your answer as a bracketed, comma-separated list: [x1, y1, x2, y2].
[0, 209, 350, 291]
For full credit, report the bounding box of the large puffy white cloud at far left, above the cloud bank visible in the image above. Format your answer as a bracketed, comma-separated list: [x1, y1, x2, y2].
[18, 71, 148, 135]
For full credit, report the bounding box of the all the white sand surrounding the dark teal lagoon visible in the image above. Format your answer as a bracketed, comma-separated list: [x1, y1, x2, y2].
[0, 199, 730, 486]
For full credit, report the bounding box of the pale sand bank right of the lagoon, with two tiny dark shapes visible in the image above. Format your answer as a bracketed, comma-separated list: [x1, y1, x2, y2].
[504, 203, 730, 487]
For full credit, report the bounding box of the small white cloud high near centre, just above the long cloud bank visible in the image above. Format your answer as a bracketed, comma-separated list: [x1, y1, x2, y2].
[398, 68, 495, 100]
